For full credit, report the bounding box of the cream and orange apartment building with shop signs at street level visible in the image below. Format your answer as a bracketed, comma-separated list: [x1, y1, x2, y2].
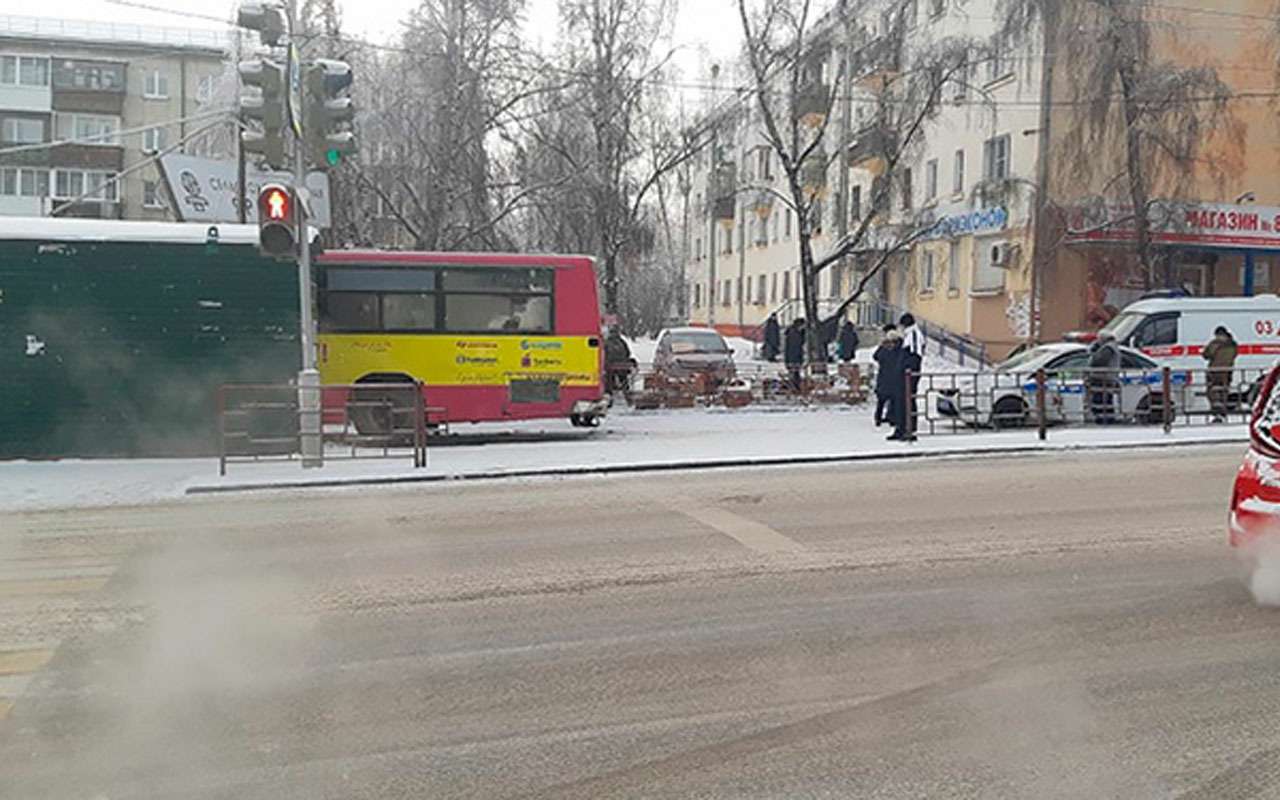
[686, 0, 1280, 357]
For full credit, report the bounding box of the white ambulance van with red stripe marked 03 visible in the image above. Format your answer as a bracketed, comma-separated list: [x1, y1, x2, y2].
[1102, 294, 1280, 406]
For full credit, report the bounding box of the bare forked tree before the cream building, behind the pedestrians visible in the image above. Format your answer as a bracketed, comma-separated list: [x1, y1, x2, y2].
[737, 0, 982, 362]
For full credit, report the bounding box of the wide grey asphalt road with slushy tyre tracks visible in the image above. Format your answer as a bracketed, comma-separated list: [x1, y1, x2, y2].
[0, 447, 1280, 800]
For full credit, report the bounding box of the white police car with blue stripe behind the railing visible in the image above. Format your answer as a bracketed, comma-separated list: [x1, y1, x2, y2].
[931, 342, 1187, 428]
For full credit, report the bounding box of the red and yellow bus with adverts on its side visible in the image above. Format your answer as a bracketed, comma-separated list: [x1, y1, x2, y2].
[315, 250, 608, 433]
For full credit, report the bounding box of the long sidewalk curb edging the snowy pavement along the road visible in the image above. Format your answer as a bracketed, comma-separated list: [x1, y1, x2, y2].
[186, 436, 1248, 495]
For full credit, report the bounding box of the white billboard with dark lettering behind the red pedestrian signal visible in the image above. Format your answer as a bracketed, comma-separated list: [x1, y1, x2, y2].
[160, 152, 330, 228]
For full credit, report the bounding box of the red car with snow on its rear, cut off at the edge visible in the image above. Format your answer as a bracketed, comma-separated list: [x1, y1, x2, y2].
[1228, 366, 1280, 548]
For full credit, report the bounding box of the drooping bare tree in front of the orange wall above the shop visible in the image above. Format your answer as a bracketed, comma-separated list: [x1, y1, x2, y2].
[992, 0, 1243, 283]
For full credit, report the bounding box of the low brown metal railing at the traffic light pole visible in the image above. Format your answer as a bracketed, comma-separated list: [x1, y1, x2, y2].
[218, 383, 444, 475]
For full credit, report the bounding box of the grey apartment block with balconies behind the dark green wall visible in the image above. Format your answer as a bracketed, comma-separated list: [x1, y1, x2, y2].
[0, 15, 229, 220]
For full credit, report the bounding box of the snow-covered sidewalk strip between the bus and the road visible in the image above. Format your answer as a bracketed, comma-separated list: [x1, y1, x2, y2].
[0, 407, 1247, 511]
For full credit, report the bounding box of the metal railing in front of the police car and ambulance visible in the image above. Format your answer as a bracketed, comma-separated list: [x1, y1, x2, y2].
[905, 367, 1270, 439]
